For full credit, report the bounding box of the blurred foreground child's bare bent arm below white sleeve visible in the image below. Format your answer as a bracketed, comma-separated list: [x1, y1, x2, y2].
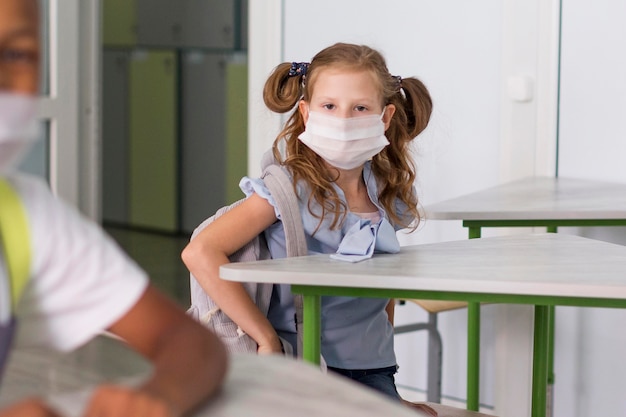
[97, 286, 228, 417]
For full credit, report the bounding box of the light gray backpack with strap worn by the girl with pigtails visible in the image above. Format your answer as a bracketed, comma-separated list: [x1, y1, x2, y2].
[187, 156, 307, 355]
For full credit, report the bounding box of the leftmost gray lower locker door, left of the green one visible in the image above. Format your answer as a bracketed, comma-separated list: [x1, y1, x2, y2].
[102, 49, 129, 225]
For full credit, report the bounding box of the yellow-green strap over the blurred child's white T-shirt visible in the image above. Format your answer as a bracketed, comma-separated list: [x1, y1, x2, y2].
[0, 178, 30, 310]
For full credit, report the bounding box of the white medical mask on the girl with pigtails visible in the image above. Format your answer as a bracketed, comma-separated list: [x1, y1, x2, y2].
[298, 109, 389, 169]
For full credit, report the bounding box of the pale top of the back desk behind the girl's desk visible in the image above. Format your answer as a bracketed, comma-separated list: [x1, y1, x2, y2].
[424, 177, 626, 220]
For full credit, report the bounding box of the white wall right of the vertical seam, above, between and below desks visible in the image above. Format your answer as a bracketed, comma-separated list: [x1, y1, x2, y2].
[555, 0, 626, 417]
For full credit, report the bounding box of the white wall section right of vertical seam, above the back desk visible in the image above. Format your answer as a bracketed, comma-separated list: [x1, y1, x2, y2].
[559, 0, 626, 182]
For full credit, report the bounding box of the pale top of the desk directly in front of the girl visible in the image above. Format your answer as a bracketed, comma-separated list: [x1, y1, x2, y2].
[220, 233, 626, 299]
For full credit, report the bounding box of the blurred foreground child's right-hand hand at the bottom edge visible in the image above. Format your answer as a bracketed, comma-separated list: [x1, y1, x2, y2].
[85, 385, 179, 417]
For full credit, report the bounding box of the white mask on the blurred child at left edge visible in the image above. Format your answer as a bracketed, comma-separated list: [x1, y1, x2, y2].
[0, 92, 39, 175]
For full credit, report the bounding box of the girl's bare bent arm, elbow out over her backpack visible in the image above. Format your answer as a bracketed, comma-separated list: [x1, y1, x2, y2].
[182, 194, 282, 353]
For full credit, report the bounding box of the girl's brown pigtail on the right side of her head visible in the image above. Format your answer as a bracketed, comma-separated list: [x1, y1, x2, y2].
[400, 77, 433, 138]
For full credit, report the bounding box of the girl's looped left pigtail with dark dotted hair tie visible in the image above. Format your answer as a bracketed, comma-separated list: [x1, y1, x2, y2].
[263, 62, 308, 113]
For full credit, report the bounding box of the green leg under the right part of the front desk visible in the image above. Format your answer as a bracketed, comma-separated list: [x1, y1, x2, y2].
[531, 306, 550, 417]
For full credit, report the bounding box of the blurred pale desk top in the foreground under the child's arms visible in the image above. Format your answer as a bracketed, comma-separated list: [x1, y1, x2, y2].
[0, 337, 427, 417]
